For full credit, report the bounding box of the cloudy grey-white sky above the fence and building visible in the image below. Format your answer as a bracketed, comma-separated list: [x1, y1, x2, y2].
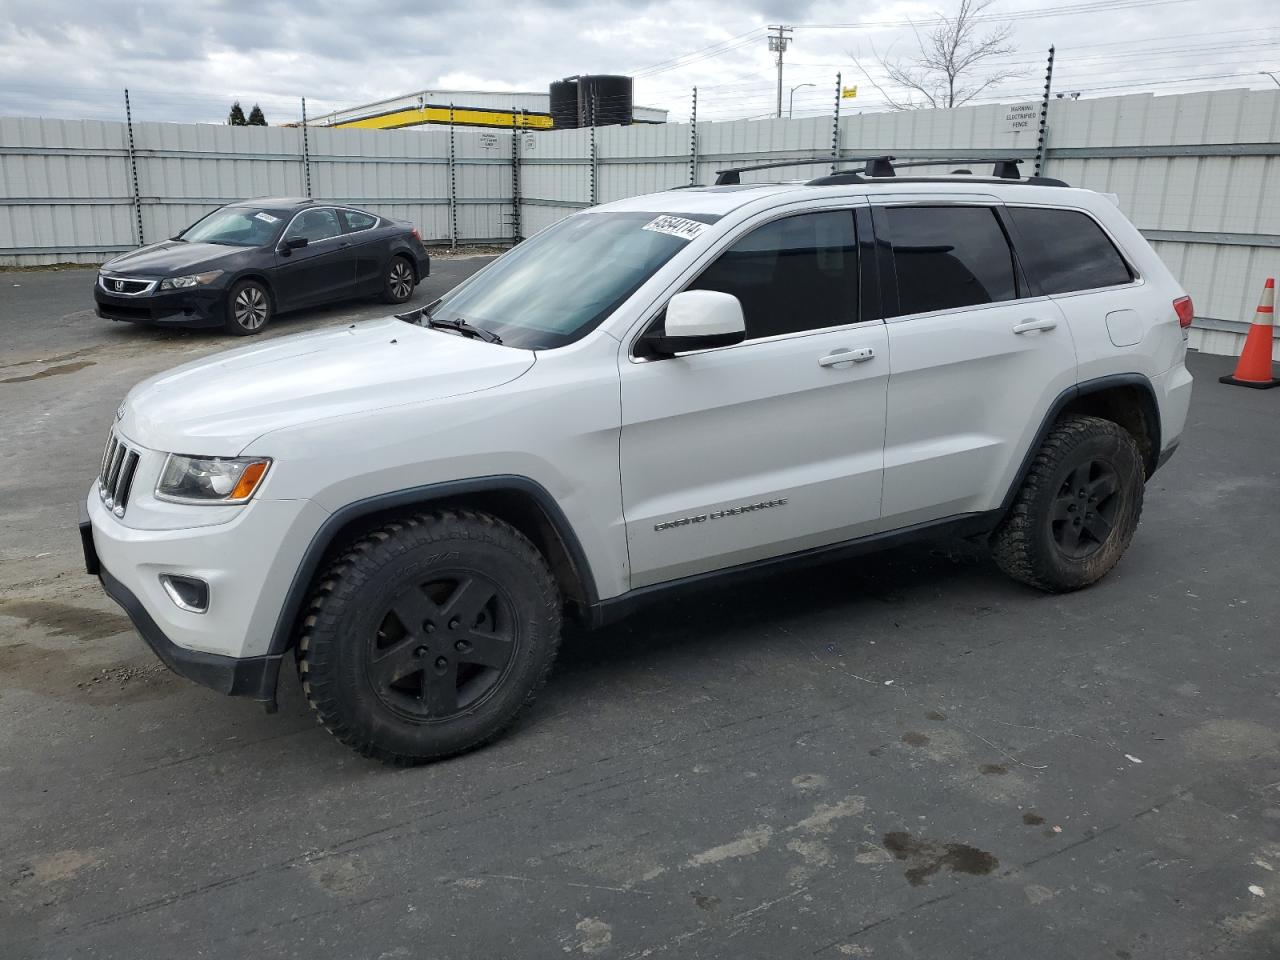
[0, 0, 1280, 123]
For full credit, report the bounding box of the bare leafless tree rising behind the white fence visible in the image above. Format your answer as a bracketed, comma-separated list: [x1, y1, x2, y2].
[854, 0, 1025, 110]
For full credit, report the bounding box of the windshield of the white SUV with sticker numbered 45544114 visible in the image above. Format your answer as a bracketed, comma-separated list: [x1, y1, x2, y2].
[431, 212, 716, 349]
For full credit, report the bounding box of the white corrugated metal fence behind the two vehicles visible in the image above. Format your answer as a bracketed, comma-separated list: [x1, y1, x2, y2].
[0, 90, 1280, 356]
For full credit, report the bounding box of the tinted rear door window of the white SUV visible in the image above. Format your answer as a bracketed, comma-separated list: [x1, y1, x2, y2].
[886, 206, 1018, 315]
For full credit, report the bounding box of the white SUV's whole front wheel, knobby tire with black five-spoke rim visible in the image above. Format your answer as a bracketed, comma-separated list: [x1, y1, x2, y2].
[297, 511, 559, 765]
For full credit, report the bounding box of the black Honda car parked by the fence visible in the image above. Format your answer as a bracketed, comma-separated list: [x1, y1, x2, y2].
[93, 198, 431, 335]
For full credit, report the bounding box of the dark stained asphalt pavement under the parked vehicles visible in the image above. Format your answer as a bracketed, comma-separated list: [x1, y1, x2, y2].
[0, 260, 1280, 960]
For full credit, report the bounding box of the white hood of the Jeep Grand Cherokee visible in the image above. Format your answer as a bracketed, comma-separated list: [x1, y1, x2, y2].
[120, 317, 535, 457]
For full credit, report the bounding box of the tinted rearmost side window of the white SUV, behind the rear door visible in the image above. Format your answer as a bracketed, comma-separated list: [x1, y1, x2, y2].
[1009, 206, 1133, 293]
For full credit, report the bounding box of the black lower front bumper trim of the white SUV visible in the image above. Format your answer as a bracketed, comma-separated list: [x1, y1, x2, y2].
[79, 503, 284, 709]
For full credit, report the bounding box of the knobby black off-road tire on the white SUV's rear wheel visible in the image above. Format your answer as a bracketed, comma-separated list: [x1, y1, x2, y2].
[991, 416, 1144, 593]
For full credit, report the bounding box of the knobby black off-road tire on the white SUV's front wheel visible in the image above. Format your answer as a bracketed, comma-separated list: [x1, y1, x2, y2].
[296, 509, 561, 765]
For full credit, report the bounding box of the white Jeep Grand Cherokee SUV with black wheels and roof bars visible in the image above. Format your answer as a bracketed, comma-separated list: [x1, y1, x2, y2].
[81, 160, 1192, 764]
